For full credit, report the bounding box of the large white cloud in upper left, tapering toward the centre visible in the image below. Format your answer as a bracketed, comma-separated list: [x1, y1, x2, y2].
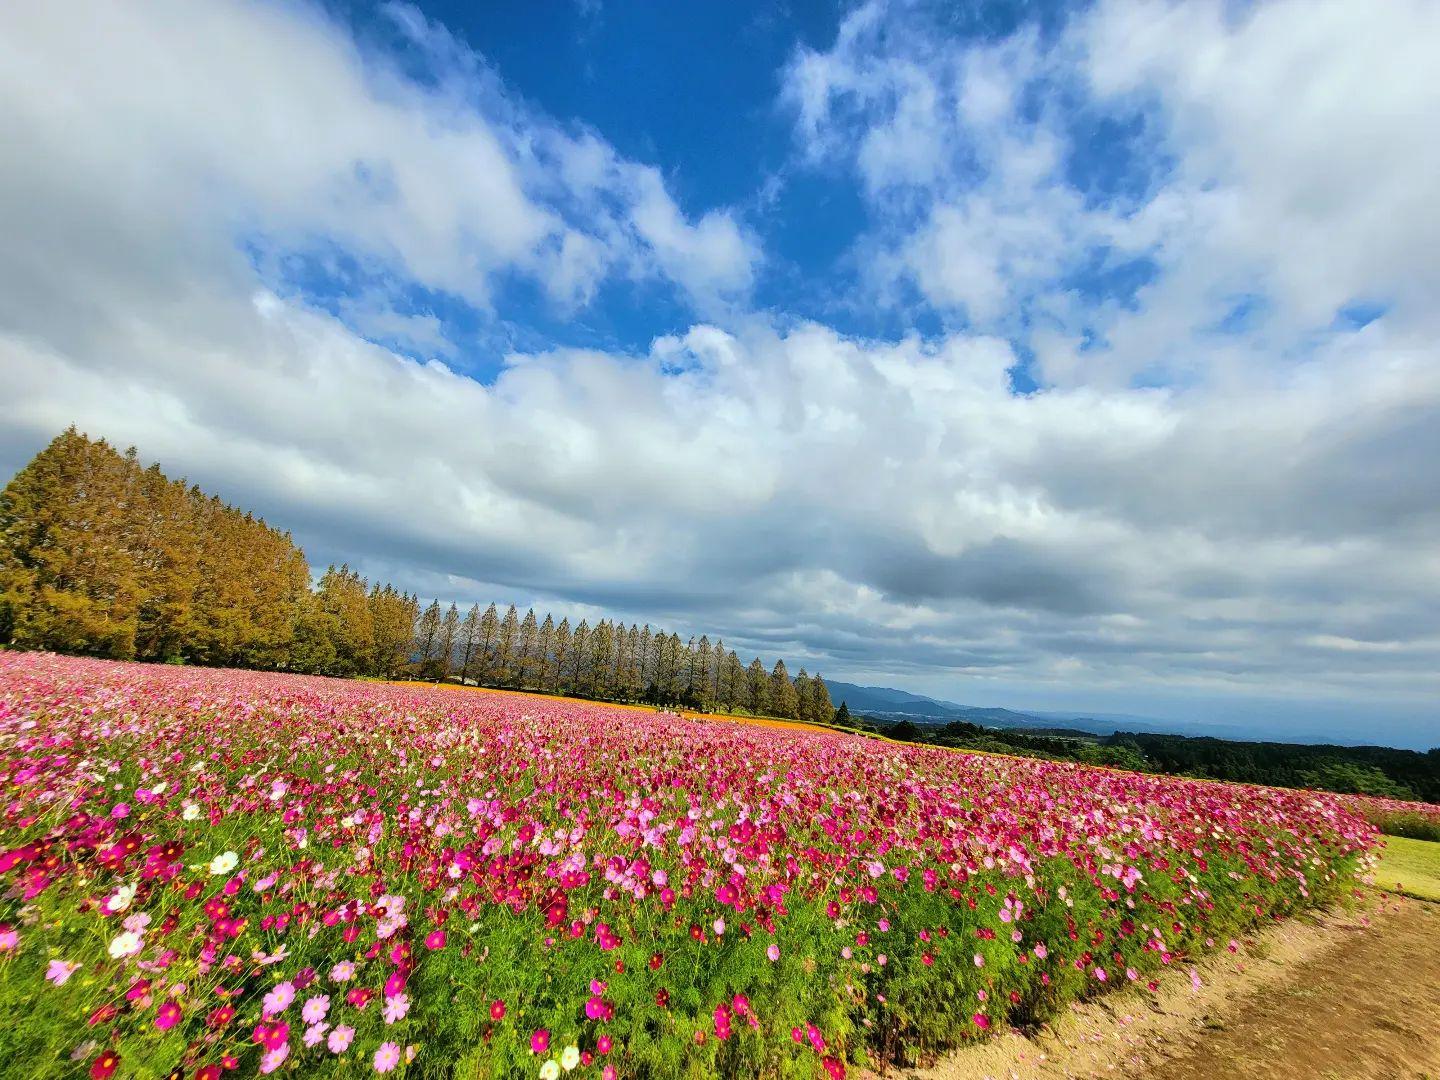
[0, 0, 757, 329]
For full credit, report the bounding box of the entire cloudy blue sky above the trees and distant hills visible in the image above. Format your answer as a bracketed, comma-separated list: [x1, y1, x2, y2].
[0, 0, 1440, 746]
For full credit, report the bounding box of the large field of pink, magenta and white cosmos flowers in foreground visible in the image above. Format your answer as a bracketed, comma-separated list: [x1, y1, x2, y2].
[0, 654, 1375, 1080]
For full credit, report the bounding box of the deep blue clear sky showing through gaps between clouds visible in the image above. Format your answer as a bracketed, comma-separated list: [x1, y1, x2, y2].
[282, 3, 1166, 368]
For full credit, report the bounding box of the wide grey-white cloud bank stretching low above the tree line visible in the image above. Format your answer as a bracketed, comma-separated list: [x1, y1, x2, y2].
[0, 279, 1440, 714]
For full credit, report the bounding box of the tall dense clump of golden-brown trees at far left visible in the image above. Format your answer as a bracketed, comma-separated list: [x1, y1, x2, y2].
[0, 428, 308, 667]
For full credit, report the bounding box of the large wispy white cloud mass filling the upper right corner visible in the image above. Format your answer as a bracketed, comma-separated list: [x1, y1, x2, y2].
[785, 0, 1440, 383]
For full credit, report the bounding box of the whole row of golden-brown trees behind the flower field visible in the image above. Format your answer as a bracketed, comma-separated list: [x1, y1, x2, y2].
[0, 426, 835, 723]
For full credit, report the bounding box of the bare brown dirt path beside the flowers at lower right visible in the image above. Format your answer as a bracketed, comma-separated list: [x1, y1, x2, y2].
[909, 894, 1440, 1080]
